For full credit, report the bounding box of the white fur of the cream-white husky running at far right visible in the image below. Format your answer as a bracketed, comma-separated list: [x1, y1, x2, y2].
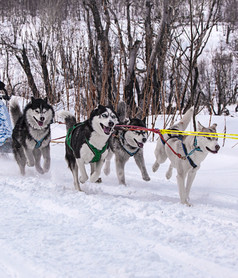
[152, 108, 220, 206]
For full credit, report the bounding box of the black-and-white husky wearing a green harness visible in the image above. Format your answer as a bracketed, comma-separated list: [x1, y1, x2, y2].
[60, 105, 118, 190]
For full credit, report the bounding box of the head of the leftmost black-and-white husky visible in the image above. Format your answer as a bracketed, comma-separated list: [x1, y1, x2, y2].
[24, 97, 54, 130]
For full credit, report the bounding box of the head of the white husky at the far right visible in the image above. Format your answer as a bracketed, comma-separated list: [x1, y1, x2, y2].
[198, 122, 220, 154]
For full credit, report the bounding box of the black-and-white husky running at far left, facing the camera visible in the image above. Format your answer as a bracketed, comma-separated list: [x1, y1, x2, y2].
[10, 97, 54, 175]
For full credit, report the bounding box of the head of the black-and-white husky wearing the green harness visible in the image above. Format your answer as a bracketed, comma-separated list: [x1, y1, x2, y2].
[90, 105, 119, 136]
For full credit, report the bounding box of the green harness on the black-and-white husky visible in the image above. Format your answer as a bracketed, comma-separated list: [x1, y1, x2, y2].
[65, 122, 108, 163]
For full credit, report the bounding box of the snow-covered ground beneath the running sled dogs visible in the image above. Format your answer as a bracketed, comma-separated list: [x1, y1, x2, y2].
[0, 113, 238, 278]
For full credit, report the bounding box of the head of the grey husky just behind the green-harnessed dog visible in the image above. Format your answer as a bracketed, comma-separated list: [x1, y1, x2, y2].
[124, 118, 148, 148]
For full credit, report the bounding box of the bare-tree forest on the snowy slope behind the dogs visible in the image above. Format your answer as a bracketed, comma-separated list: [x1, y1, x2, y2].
[0, 0, 238, 120]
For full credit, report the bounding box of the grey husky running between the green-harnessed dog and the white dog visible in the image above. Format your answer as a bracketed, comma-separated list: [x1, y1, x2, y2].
[104, 101, 150, 185]
